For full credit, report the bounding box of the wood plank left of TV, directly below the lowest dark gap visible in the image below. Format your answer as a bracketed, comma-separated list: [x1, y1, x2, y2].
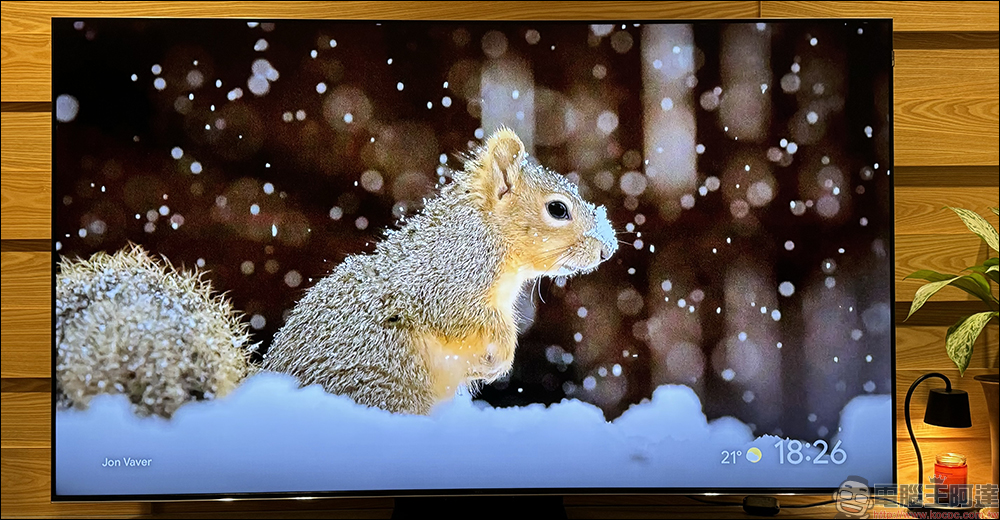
[0, 392, 52, 449]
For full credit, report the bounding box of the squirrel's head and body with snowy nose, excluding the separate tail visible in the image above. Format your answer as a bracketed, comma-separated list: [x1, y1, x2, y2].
[262, 127, 618, 415]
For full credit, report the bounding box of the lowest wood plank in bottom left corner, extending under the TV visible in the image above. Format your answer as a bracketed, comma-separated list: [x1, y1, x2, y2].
[0, 448, 151, 518]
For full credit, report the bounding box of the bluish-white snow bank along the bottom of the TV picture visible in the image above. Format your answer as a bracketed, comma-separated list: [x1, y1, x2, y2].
[55, 373, 893, 495]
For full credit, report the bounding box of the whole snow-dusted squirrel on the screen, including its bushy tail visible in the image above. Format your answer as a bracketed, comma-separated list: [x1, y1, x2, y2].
[55, 128, 618, 418]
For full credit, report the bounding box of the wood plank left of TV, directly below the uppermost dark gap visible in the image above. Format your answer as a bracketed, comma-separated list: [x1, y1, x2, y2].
[0, 112, 52, 173]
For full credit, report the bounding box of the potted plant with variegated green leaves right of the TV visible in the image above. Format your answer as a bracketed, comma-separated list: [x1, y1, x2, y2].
[906, 207, 1000, 492]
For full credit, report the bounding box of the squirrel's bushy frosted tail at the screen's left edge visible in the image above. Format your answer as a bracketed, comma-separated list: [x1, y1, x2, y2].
[56, 245, 250, 418]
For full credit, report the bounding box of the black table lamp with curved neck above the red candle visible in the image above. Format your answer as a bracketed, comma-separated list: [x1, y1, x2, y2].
[903, 372, 972, 510]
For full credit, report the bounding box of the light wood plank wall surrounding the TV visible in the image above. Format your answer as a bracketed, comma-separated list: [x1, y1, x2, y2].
[0, 1, 1000, 517]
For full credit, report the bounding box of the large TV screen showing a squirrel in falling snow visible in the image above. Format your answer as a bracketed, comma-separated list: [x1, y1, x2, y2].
[52, 13, 895, 500]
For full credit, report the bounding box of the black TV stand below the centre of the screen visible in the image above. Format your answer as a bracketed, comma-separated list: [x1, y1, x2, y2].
[392, 495, 566, 520]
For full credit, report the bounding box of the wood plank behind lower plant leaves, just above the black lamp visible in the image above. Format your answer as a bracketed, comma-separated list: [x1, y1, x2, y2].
[896, 324, 1000, 371]
